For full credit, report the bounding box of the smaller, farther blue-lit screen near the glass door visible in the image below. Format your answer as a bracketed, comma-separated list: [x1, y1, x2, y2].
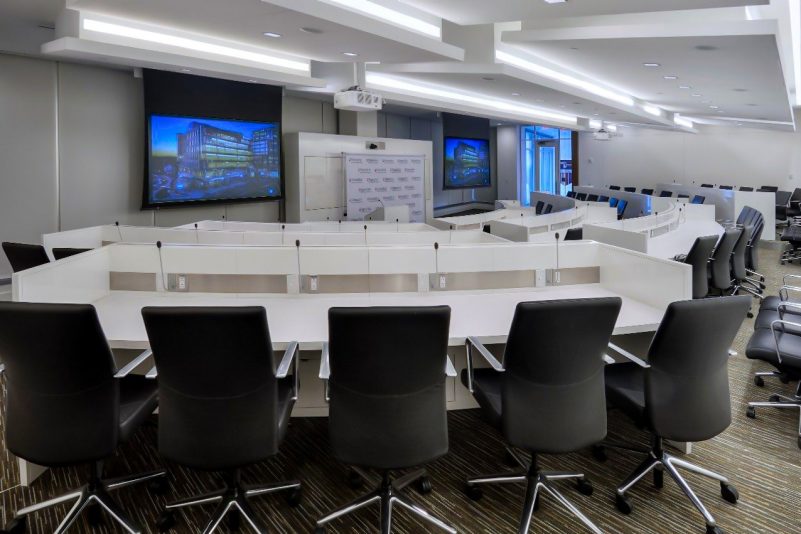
[444, 137, 492, 189]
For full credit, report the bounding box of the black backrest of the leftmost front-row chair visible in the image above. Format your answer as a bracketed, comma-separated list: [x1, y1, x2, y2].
[0, 302, 119, 467]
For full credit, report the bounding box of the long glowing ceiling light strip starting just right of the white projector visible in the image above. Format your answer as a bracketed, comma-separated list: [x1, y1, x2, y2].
[367, 72, 578, 124]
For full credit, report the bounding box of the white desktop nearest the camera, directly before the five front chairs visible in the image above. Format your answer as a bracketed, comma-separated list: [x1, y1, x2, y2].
[94, 284, 664, 350]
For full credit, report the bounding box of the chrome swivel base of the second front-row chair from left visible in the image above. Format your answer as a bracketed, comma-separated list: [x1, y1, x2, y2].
[156, 470, 301, 534]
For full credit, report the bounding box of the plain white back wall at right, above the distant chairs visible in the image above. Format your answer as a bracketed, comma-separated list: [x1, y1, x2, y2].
[579, 116, 801, 191]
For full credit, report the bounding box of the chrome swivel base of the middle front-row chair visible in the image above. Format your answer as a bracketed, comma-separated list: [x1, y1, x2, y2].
[314, 468, 456, 534]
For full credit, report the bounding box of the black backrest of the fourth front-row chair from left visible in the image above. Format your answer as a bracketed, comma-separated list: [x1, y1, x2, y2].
[501, 297, 622, 454]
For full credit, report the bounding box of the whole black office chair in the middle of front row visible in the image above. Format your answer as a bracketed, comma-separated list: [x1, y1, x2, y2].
[315, 306, 456, 534]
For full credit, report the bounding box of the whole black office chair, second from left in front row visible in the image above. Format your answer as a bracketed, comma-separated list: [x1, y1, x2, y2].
[142, 306, 301, 534]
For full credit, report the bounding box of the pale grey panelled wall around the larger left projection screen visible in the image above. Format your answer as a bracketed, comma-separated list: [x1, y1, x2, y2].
[0, 54, 337, 280]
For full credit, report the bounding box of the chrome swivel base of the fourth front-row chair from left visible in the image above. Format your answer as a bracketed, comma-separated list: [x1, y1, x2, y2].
[465, 448, 601, 534]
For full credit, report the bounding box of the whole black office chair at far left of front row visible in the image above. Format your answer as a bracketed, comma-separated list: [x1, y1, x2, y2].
[0, 302, 166, 534]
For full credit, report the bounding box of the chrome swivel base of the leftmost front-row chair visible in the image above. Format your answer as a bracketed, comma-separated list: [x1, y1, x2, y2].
[0, 462, 167, 534]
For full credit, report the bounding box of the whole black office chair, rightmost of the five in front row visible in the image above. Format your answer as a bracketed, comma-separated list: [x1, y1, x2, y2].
[606, 297, 751, 534]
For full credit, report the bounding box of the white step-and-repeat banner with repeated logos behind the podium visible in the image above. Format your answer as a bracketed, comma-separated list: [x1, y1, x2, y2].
[344, 154, 426, 222]
